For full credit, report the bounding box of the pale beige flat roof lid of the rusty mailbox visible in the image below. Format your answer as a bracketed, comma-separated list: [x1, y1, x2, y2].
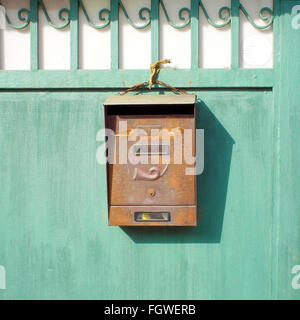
[104, 94, 196, 106]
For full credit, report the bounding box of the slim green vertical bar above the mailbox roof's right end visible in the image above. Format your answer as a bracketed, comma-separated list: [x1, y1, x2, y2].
[191, 0, 199, 69]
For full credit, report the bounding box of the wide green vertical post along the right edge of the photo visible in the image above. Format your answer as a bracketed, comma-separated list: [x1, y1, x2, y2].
[276, 0, 300, 299]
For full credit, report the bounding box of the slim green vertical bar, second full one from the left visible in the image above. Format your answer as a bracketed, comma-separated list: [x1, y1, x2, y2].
[70, 0, 79, 70]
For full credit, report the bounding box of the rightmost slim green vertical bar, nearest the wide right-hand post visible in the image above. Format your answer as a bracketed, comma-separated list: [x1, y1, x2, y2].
[231, 0, 240, 69]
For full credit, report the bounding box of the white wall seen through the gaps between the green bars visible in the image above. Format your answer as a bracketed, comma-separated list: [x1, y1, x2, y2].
[0, 0, 273, 70]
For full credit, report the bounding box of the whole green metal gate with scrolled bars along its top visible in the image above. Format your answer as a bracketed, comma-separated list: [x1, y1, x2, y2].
[0, 0, 300, 299]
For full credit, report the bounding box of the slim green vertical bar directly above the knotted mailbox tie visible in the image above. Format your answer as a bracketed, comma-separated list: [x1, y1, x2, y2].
[151, 0, 160, 63]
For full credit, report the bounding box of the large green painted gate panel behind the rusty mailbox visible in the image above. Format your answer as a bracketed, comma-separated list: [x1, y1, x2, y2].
[0, 90, 274, 299]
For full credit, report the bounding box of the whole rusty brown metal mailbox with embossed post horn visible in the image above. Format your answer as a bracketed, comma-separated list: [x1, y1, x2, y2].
[104, 94, 197, 226]
